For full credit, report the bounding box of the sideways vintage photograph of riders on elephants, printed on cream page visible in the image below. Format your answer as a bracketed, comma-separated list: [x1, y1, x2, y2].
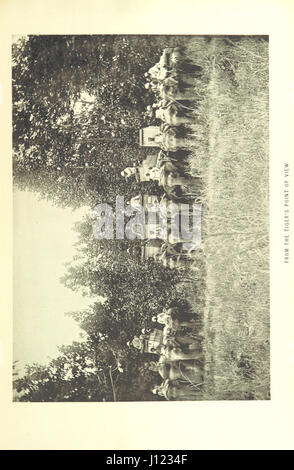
[11, 34, 268, 406]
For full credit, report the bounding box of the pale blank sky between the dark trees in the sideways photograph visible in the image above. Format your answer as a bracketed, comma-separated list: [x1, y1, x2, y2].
[13, 190, 93, 372]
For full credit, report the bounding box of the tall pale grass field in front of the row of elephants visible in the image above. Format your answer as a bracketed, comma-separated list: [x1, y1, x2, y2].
[186, 37, 270, 400]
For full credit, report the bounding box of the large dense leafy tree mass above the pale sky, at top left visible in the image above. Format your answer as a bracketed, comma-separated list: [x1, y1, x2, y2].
[12, 36, 172, 208]
